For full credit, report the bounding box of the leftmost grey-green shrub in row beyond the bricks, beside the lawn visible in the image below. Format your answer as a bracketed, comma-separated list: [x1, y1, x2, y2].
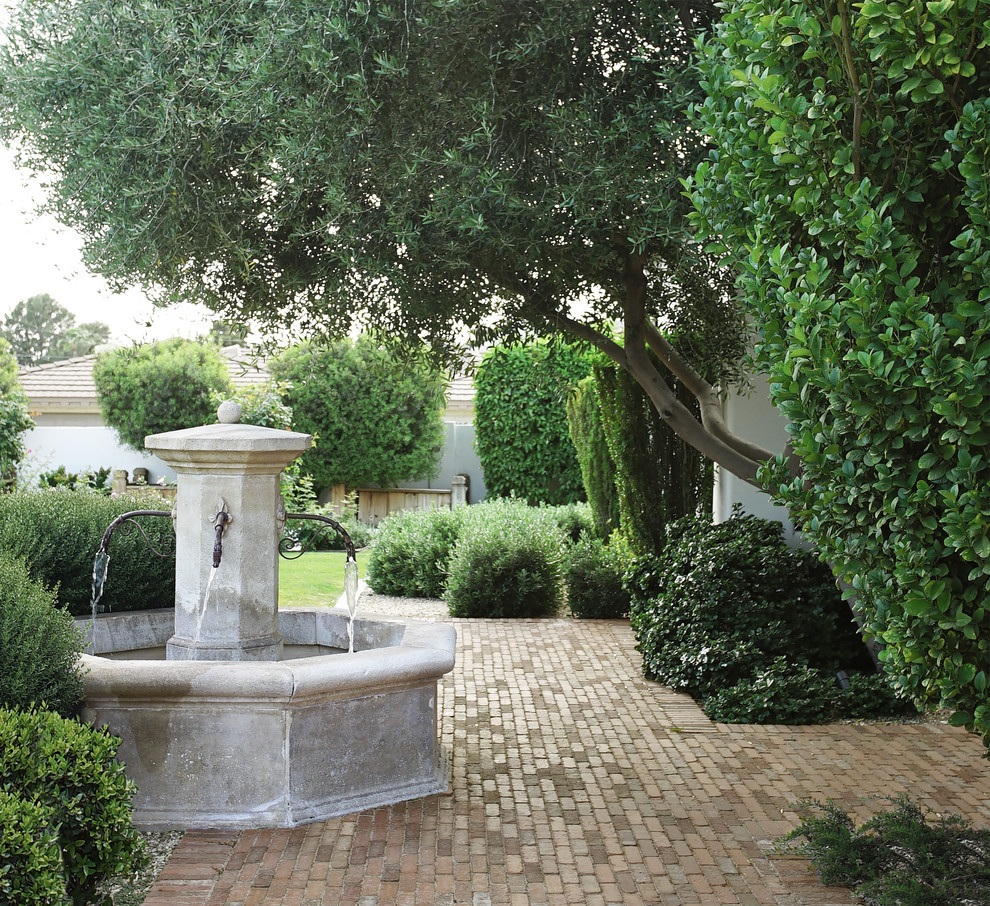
[366, 504, 468, 598]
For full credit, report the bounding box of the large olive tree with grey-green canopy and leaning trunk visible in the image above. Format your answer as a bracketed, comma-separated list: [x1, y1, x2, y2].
[0, 0, 771, 481]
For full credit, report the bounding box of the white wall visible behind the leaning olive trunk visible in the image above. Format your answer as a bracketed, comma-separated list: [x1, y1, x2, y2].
[712, 374, 800, 543]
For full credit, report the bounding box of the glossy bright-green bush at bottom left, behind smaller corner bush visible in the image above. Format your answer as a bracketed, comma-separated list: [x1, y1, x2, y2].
[0, 709, 143, 906]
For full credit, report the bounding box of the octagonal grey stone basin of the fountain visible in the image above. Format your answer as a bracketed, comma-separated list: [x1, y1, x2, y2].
[82, 608, 455, 830]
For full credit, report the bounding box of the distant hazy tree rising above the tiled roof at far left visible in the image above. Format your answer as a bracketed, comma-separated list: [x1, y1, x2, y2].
[0, 293, 110, 365]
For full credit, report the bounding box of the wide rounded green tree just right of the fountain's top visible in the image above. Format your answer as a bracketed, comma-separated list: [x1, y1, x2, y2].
[270, 337, 444, 488]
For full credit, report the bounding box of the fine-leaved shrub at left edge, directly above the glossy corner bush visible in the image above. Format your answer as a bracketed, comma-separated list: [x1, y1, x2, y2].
[0, 550, 83, 715]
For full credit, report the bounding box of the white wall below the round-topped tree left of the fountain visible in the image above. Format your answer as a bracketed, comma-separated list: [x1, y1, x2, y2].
[25, 425, 175, 484]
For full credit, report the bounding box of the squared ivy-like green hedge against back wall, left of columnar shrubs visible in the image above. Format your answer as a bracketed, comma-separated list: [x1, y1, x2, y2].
[474, 343, 592, 505]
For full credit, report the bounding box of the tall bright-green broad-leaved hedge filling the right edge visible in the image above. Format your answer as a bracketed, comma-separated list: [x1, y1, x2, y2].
[691, 0, 990, 744]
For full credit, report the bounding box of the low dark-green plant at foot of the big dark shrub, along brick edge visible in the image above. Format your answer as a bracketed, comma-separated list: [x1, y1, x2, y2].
[704, 657, 915, 724]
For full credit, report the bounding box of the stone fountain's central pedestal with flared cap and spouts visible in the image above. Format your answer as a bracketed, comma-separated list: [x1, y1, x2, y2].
[145, 423, 311, 661]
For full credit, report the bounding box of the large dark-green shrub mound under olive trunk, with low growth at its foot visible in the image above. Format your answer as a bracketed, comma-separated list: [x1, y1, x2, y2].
[627, 514, 905, 723]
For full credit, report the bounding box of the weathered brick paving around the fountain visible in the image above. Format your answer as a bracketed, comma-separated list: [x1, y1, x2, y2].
[145, 620, 990, 906]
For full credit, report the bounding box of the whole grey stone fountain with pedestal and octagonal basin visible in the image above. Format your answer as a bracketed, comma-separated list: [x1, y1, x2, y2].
[82, 404, 455, 829]
